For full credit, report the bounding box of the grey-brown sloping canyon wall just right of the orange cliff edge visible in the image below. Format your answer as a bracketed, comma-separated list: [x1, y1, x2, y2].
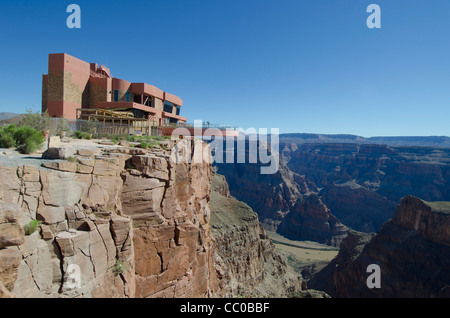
[211, 174, 301, 297]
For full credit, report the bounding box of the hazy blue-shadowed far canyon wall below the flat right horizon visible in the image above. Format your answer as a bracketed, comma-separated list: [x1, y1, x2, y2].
[280, 142, 450, 232]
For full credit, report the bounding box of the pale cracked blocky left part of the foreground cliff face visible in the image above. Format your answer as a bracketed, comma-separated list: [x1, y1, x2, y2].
[0, 157, 134, 297]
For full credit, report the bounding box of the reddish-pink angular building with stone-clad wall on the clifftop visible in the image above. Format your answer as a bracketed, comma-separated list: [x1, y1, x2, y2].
[42, 53, 187, 126]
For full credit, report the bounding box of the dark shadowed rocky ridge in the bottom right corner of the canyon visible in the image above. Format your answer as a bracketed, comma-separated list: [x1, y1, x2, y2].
[308, 196, 450, 298]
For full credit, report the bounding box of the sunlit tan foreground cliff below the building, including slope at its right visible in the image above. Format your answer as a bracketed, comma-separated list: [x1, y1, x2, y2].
[0, 140, 301, 298]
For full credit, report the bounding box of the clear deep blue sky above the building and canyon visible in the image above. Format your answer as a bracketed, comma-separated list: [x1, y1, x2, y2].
[0, 0, 450, 137]
